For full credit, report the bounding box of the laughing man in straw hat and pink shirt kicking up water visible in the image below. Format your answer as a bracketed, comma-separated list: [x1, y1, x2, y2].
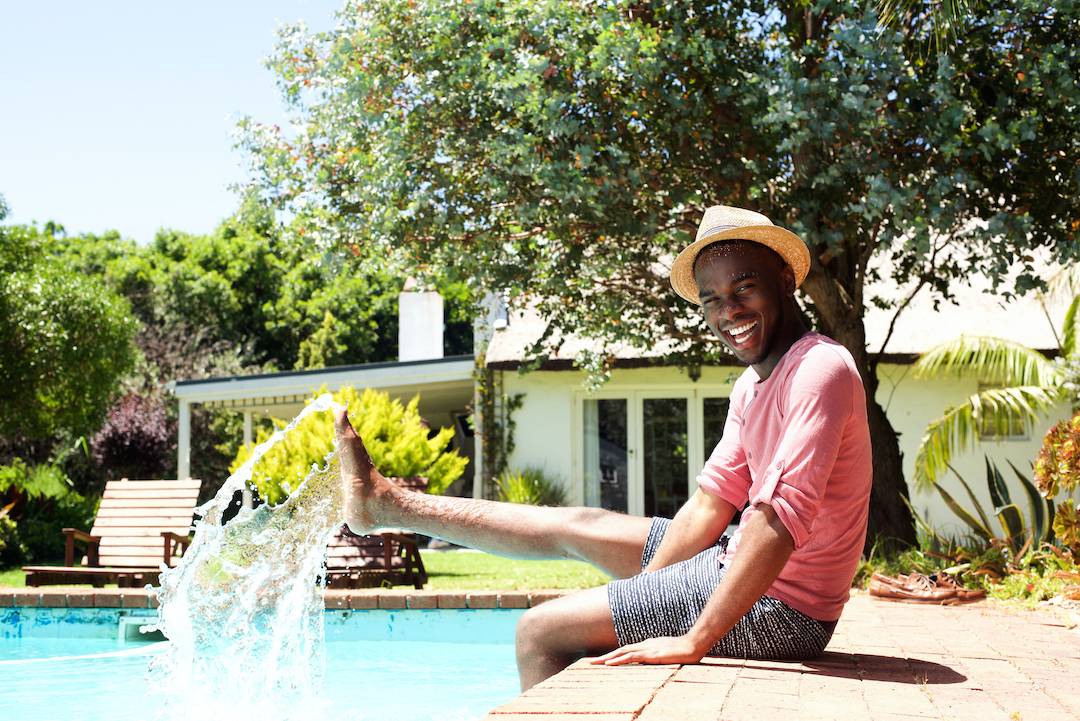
[337, 206, 872, 690]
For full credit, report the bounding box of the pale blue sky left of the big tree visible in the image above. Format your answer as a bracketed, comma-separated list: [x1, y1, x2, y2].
[0, 0, 343, 243]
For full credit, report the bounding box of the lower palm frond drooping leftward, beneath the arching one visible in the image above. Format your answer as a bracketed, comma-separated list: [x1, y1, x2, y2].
[915, 385, 1061, 489]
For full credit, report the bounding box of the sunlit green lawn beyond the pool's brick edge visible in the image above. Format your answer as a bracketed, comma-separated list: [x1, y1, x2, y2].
[0, 550, 608, 590]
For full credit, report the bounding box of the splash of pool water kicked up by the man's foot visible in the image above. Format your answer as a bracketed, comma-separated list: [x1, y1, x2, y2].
[150, 394, 342, 721]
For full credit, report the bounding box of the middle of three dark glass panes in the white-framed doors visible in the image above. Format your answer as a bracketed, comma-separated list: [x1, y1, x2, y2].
[642, 398, 688, 518]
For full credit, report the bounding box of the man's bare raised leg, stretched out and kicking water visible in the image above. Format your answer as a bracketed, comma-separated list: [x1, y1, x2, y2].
[335, 411, 650, 578]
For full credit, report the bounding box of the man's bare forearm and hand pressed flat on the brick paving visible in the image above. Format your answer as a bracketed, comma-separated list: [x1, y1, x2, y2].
[593, 504, 795, 666]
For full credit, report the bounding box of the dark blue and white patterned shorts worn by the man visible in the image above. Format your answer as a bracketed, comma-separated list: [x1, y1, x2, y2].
[607, 518, 836, 661]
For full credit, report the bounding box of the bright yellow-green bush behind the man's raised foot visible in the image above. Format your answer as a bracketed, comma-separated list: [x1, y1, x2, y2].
[230, 386, 469, 503]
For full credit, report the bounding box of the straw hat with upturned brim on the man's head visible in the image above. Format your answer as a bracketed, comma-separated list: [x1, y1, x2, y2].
[672, 205, 810, 305]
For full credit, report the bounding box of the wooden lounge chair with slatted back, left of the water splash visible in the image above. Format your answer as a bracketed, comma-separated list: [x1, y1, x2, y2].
[23, 478, 202, 587]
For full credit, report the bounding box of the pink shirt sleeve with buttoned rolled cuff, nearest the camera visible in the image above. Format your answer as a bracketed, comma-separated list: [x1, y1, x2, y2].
[750, 351, 854, 548]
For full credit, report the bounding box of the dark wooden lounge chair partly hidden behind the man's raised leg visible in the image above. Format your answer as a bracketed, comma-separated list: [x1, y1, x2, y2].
[326, 478, 428, 588]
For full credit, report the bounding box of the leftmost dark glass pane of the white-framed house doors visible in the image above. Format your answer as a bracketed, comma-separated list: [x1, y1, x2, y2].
[583, 398, 630, 513]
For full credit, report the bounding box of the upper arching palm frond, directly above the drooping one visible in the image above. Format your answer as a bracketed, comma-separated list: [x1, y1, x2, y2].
[915, 336, 1064, 386]
